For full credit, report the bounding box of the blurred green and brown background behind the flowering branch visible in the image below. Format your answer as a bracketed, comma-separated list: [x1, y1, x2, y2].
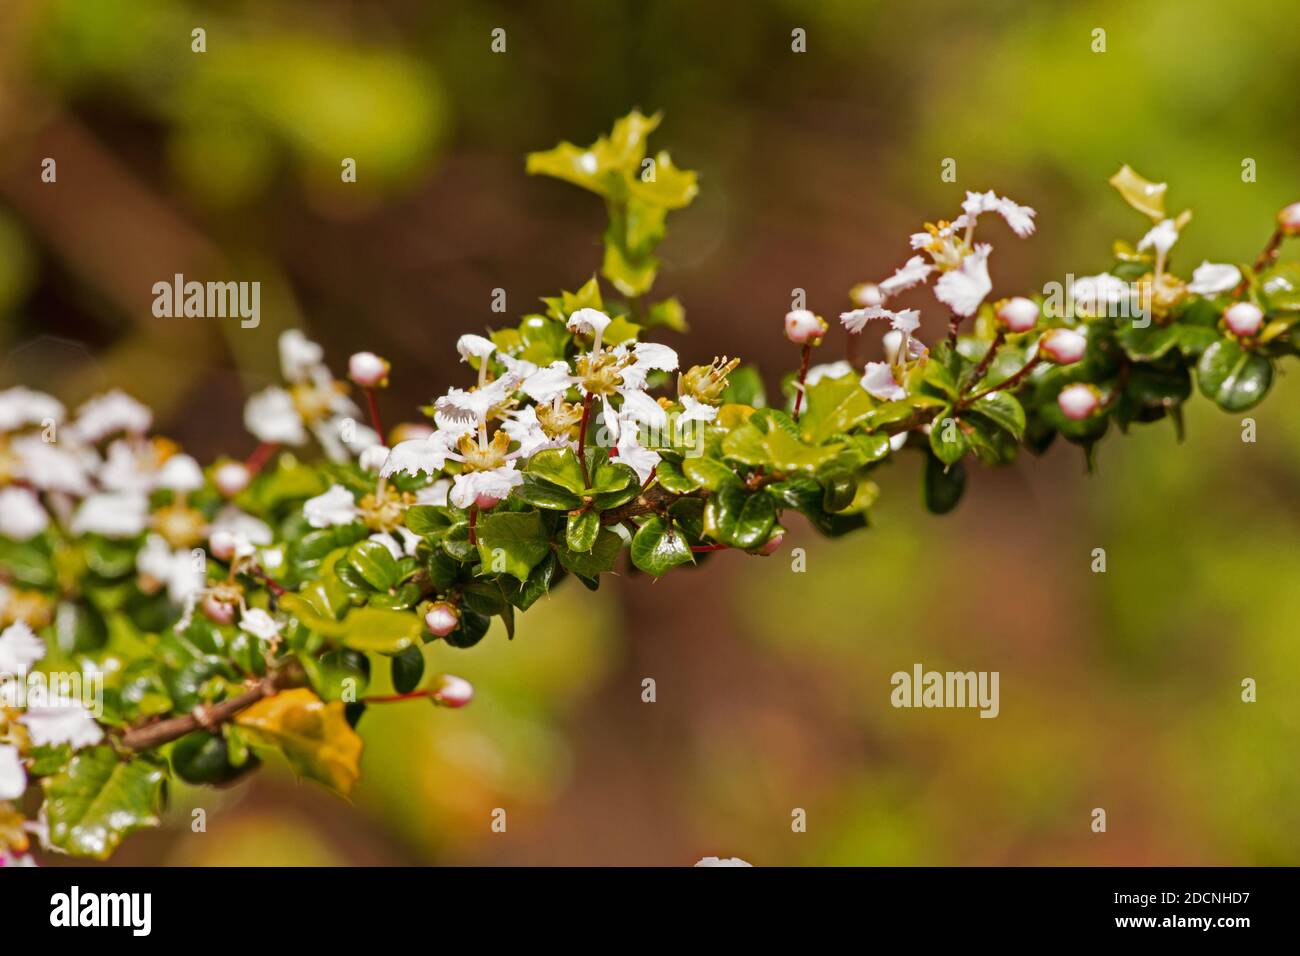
[0, 0, 1300, 865]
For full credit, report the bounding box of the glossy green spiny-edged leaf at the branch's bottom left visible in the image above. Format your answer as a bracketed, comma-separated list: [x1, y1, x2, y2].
[42, 747, 166, 860]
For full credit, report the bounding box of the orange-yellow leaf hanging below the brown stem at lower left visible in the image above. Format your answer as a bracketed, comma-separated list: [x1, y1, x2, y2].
[235, 687, 361, 796]
